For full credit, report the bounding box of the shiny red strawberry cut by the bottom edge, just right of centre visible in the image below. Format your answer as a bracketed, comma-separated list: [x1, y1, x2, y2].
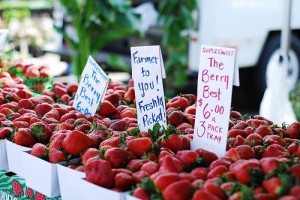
[163, 180, 193, 200]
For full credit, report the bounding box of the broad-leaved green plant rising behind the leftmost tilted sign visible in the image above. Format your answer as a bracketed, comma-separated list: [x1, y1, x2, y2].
[58, 0, 139, 77]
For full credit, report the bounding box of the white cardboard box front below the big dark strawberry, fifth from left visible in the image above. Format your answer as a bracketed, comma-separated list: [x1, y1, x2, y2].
[80, 179, 126, 200]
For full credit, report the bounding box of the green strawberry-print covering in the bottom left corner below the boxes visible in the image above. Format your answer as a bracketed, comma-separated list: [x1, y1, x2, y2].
[0, 170, 61, 200]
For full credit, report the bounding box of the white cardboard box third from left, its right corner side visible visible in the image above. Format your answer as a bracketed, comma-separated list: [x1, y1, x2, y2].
[22, 151, 60, 198]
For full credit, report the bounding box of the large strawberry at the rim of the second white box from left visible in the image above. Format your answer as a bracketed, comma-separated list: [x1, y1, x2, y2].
[13, 128, 36, 147]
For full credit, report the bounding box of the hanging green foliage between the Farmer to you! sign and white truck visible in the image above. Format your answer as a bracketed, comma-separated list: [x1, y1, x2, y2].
[159, 0, 197, 94]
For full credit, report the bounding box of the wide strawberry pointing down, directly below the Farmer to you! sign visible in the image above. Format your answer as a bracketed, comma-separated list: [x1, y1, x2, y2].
[127, 137, 152, 157]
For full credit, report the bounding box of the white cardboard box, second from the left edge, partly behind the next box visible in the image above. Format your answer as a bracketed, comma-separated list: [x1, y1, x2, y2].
[5, 140, 30, 177]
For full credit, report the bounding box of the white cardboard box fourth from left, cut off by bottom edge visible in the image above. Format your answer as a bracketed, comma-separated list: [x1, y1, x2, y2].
[56, 164, 85, 200]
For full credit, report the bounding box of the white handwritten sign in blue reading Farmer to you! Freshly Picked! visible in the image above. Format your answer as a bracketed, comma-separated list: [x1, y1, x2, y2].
[131, 46, 166, 131]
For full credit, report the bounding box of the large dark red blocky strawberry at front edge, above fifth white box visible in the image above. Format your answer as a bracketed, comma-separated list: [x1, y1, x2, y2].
[85, 158, 114, 188]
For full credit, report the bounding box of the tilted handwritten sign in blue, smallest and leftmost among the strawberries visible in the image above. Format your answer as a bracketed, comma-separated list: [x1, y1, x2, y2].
[73, 56, 109, 116]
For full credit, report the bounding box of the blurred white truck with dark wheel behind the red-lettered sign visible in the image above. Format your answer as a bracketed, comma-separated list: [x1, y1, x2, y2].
[188, 0, 300, 102]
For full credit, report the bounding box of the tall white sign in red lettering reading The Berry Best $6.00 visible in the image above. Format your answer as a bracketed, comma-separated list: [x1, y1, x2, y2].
[192, 46, 236, 157]
